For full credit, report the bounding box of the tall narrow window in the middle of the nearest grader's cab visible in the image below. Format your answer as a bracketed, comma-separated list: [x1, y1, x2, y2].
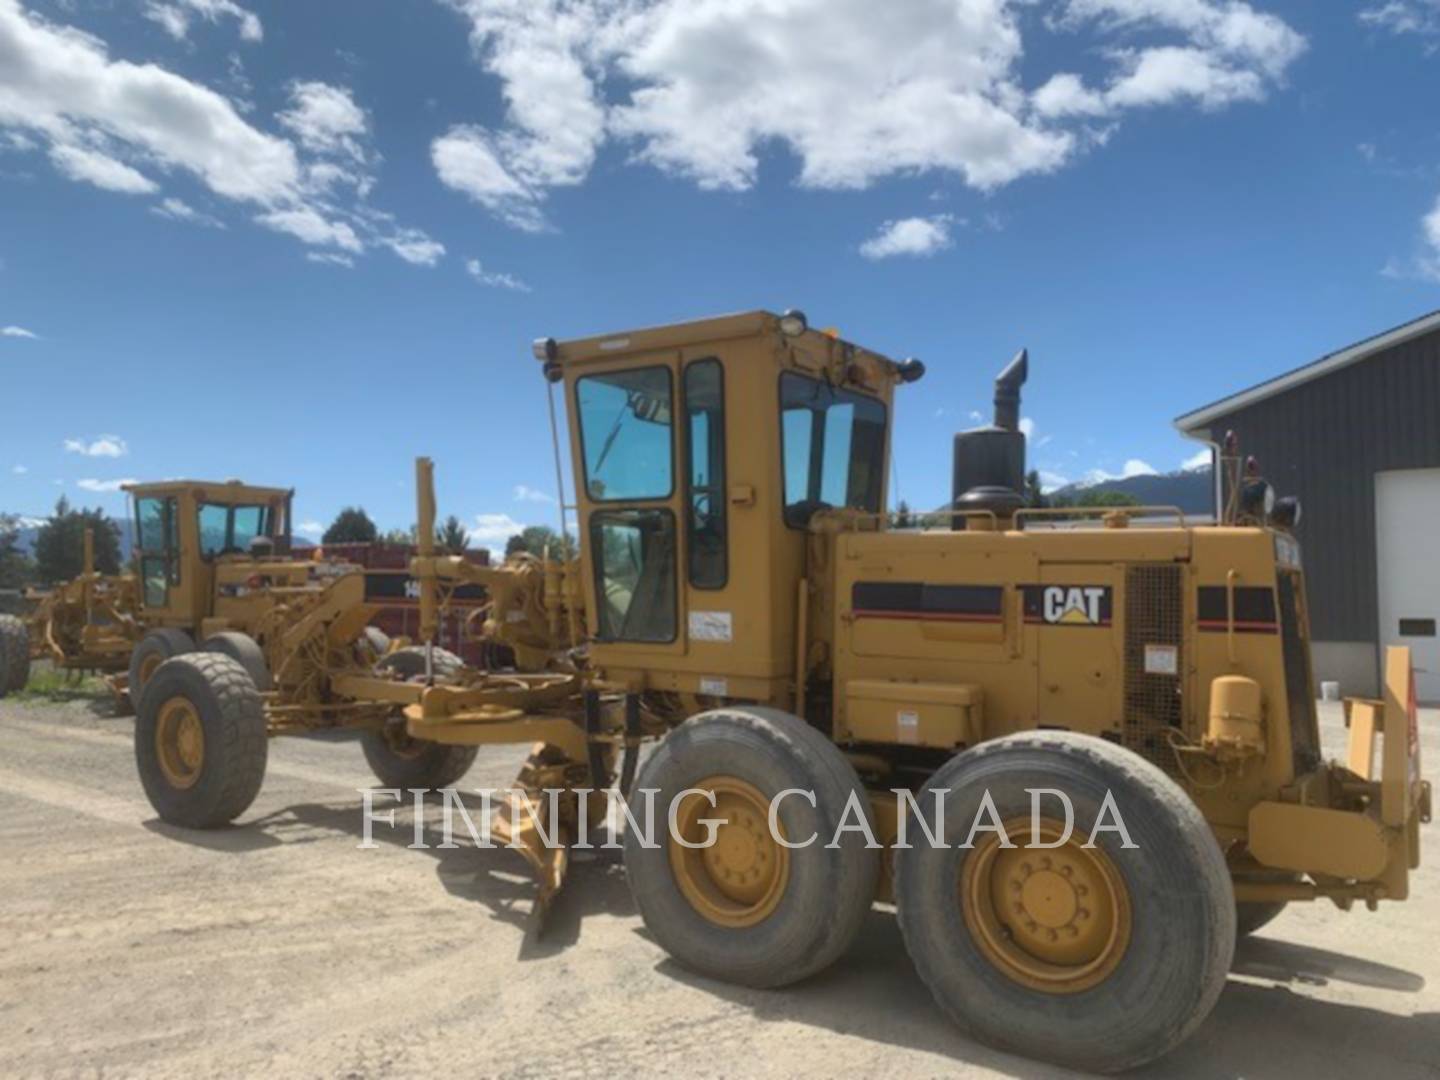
[684, 360, 729, 589]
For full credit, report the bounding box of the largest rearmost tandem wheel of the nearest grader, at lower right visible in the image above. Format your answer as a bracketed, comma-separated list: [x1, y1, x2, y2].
[896, 732, 1236, 1073]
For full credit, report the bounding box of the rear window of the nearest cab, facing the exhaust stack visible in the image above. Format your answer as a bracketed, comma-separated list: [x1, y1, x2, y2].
[780, 372, 886, 528]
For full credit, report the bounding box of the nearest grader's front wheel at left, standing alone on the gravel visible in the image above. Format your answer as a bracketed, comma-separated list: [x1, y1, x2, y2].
[135, 652, 269, 829]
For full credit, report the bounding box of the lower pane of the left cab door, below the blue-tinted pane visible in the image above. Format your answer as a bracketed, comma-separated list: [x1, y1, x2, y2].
[590, 510, 675, 641]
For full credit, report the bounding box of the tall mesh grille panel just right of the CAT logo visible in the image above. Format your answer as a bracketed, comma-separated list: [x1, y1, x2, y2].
[1125, 564, 1185, 773]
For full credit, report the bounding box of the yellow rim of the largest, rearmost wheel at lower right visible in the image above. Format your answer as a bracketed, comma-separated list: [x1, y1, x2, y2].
[959, 818, 1130, 994]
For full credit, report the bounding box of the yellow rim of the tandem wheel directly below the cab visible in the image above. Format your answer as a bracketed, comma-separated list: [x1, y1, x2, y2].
[670, 776, 791, 927]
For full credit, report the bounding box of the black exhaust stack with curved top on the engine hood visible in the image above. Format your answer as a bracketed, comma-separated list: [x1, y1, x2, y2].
[950, 348, 1030, 528]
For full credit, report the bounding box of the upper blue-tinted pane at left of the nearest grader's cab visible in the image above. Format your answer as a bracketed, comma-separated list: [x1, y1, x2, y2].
[575, 367, 674, 503]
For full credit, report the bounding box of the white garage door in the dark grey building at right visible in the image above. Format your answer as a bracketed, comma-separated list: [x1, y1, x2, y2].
[1375, 469, 1440, 701]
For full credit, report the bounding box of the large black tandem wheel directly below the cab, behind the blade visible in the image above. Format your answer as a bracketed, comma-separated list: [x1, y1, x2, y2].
[625, 707, 880, 986]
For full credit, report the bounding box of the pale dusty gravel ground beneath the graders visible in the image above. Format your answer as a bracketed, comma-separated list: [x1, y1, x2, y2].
[0, 697, 1440, 1080]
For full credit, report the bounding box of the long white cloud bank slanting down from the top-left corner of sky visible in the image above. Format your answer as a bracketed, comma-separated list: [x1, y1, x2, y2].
[0, 11, 442, 265]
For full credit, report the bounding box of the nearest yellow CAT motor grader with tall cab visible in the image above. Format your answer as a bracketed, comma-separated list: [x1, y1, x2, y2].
[126, 312, 1430, 1070]
